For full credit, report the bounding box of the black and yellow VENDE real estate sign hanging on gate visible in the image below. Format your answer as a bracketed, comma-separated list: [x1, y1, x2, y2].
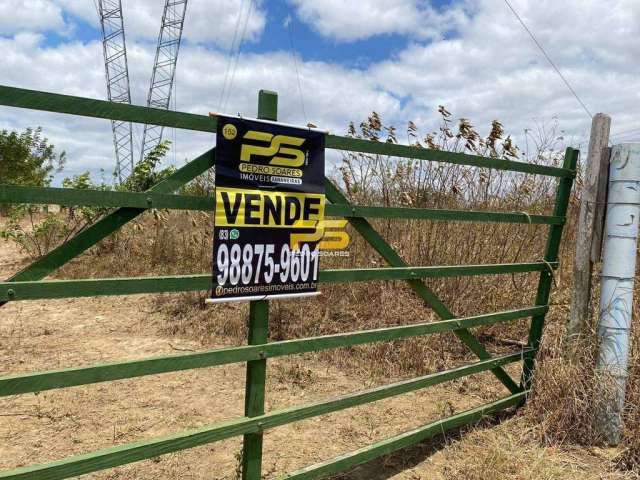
[212, 116, 325, 302]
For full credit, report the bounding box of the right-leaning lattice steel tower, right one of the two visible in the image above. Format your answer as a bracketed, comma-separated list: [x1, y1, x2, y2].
[140, 0, 187, 159]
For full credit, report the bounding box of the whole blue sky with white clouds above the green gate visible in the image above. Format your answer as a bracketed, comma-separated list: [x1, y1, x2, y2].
[0, 0, 640, 182]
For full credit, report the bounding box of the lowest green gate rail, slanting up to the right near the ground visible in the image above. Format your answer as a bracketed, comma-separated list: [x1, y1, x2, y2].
[279, 391, 529, 480]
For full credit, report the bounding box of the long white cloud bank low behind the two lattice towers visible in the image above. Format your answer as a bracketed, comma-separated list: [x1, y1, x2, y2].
[0, 34, 400, 182]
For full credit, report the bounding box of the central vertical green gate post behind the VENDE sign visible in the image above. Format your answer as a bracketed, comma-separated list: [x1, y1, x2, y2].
[242, 90, 278, 480]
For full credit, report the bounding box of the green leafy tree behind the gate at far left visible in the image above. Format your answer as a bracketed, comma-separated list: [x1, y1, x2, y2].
[0, 127, 66, 187]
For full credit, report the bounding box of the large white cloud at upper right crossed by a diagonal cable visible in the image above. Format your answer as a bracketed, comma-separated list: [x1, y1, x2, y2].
[370, 0, 640, 144]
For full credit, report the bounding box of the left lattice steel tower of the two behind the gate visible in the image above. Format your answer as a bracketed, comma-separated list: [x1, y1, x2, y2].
[98, 0, 133, 182]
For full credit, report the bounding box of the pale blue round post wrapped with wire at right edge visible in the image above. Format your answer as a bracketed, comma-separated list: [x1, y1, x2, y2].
[597, 143, 640, 445]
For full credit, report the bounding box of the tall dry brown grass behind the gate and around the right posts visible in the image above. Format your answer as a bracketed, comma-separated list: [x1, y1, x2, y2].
[52, 208, 640, 472]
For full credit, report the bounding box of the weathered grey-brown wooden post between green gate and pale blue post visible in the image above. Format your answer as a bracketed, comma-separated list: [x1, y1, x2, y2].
[567, 113, 611, 346]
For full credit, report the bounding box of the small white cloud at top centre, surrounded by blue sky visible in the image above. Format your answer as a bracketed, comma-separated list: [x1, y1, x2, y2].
[290, 0, 465, 41]
